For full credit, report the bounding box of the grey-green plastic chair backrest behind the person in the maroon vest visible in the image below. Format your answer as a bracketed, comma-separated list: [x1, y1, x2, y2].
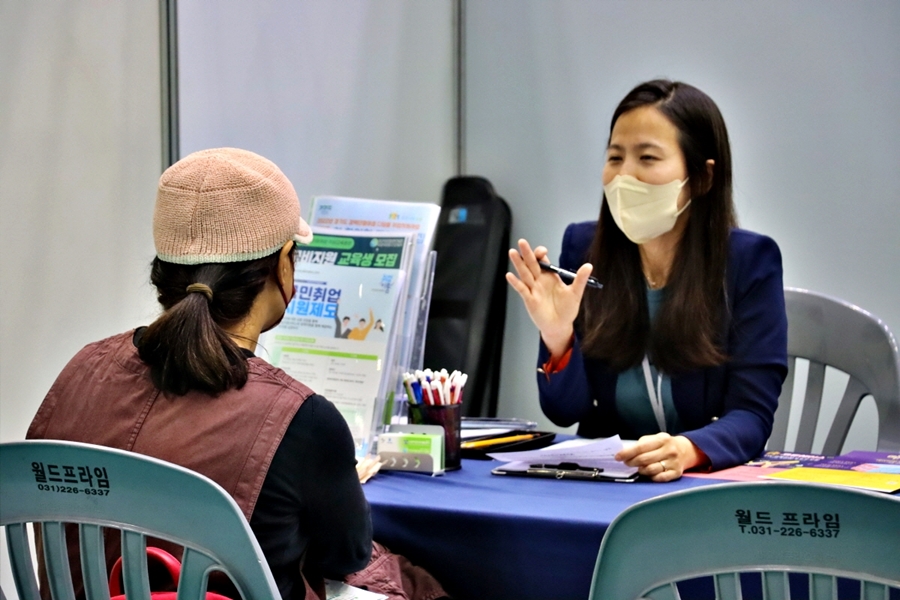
[0, 440, 281, 600]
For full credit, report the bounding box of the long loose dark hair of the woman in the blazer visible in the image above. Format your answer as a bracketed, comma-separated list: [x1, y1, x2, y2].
[579, 80, 737, 373]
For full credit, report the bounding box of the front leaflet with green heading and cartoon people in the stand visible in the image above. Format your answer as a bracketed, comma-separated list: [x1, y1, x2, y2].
[257, 228, 414, 456]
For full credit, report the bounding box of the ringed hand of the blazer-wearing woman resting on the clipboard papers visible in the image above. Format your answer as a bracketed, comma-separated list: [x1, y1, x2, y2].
[615, 433, 706, 482]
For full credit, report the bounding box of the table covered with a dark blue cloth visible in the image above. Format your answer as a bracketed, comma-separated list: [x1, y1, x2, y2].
[363, 460, 711, 600]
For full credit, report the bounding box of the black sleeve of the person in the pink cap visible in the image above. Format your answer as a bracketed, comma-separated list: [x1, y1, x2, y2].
[250, 395, 372, 597]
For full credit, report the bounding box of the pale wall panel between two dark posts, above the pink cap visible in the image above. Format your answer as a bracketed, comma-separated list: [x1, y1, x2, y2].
[178, 0, 454, 209]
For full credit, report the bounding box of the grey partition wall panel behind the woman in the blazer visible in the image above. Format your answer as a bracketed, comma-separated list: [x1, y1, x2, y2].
[465, 0, 900, 448]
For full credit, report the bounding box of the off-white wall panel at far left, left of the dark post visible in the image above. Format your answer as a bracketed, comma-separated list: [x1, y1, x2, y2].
[0, 0, 161, 600]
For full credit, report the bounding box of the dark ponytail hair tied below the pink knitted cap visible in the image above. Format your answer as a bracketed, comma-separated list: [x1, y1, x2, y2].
[138, 246, 292, 396]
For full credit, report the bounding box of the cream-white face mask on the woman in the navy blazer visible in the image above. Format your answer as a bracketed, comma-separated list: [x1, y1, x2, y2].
[603, 175, 691, 244]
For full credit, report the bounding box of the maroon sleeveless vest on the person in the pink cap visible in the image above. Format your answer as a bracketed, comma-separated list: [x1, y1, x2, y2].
[27, 332, 313, 588]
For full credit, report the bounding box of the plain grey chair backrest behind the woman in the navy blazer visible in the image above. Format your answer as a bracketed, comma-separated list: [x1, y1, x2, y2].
[767, 288, 900, 455]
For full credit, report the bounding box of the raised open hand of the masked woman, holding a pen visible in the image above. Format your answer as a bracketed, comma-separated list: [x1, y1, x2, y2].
[506, 239, 593, 357]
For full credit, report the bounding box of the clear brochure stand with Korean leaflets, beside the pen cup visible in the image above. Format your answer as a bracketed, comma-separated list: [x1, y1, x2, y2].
[258, 196, 440, 458]
